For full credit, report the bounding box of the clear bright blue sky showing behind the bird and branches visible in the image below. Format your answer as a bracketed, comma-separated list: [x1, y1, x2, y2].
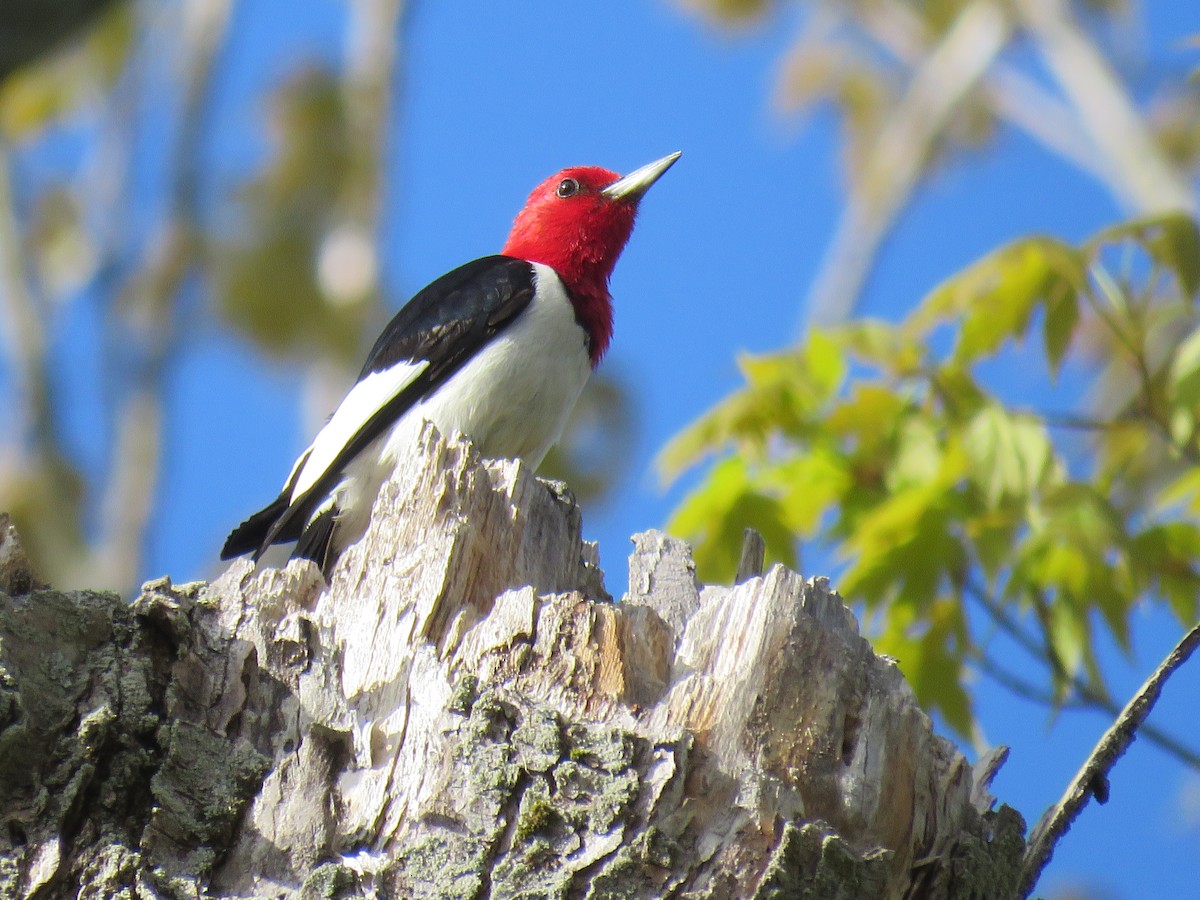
[32, 0, 1200, 898]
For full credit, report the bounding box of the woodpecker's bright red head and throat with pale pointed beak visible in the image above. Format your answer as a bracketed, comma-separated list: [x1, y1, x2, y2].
[500, 154, 679, 364]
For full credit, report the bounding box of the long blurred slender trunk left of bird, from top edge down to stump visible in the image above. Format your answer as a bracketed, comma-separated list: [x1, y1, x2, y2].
[97, 0, 233, 588]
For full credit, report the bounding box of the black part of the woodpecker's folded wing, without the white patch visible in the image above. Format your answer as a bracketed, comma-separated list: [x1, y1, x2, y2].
[256, 256, 535, 556]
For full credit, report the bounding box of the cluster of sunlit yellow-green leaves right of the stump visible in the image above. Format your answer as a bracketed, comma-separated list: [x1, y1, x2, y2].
[662, 216, 1200, 744]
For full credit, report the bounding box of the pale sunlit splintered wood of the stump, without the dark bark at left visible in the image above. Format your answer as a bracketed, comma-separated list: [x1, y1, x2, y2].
[199, 428, 1012, 898]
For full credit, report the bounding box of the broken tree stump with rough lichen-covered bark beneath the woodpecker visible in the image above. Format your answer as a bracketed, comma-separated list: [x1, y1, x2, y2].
[0, 427, 1024, 900]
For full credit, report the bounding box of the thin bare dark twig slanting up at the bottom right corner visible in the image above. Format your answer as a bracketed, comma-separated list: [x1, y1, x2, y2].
[1019, 625, 1200, 898]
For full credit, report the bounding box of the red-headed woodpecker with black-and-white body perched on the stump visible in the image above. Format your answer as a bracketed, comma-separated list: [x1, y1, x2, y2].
[221, 152, 680, 577]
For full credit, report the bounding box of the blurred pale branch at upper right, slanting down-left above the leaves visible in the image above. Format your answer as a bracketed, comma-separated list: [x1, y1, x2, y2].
[806, 0, 1010, 323]
